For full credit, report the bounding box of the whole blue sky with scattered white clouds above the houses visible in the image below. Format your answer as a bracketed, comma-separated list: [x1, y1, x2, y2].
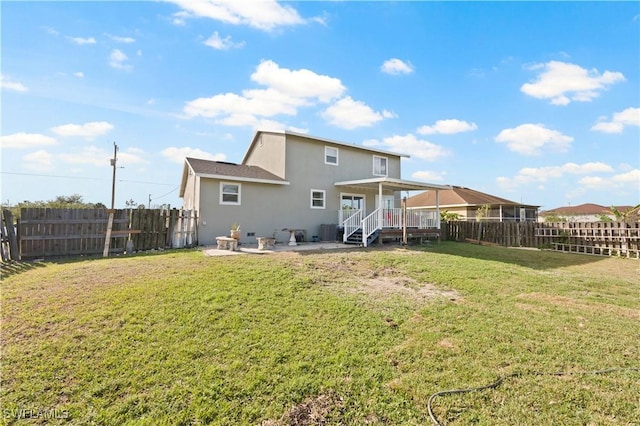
[0, 0, 640, 209]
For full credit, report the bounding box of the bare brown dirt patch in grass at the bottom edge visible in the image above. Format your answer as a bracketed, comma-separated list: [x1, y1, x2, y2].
[260, 395, 343, 426]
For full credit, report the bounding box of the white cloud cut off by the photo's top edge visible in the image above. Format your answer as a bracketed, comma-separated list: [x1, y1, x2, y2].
[166, 0, 305, 31]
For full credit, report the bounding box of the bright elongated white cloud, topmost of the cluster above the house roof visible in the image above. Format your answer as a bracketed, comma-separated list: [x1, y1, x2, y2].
[251, 61, 345, 102]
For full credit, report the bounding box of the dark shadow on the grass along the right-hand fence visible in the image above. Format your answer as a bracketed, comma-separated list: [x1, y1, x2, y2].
[407, 241, 607, 270]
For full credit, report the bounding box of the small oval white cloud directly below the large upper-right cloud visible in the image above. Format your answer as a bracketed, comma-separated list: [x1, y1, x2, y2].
[495, 124, 573, 155]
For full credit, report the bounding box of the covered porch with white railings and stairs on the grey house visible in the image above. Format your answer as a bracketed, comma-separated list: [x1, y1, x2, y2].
[335, 177, 451, 247]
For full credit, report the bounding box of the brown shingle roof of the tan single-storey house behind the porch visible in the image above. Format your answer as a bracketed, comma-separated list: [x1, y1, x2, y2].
[407, 186, 524, 207]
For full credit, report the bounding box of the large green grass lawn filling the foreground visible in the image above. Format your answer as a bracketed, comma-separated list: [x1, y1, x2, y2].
[0, 242, 640, 426]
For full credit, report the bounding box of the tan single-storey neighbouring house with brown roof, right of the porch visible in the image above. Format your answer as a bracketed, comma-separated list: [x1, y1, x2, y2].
[407, 186, 539, 222]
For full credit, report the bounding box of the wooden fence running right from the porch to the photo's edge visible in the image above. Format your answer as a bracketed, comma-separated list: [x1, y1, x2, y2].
[442, 222, 640, 258]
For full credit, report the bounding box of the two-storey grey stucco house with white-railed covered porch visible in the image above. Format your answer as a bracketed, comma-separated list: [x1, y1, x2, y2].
[180, 131, 450, 246]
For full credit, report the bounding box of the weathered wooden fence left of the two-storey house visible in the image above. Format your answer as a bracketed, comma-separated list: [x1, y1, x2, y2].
[2, 208, 198, 260]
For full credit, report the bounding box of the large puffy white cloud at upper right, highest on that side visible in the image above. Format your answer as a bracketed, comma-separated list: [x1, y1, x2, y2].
[520, 61, 625, 105]
